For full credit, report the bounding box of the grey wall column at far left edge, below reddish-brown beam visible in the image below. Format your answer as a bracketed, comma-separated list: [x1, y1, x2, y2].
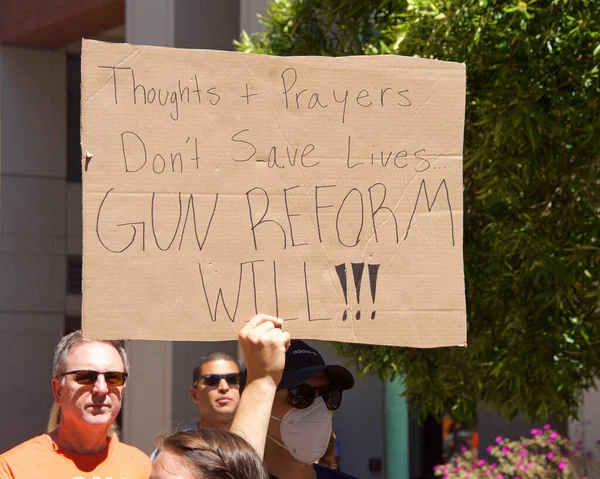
[0, 47, 67, 452]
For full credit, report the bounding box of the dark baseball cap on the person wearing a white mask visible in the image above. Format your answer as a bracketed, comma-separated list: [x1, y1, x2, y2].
[240, 339, 354, 391]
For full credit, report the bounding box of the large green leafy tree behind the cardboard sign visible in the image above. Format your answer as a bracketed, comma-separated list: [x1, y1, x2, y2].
[238, 0, 600, 419]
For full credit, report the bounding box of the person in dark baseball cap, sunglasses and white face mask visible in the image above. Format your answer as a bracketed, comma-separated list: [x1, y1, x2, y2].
[240, 340, 354, 479]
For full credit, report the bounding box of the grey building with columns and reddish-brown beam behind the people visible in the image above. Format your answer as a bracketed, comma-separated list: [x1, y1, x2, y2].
[0, 0, 600, 478]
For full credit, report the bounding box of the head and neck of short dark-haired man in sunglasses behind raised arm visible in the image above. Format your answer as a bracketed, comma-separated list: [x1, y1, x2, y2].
[190, 352, 240, 430]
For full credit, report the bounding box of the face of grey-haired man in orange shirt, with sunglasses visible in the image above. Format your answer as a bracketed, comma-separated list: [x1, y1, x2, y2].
[52, 341, 125, 426]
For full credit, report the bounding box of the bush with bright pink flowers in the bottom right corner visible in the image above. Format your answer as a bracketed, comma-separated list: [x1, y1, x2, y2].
[435, 424, 600, 479]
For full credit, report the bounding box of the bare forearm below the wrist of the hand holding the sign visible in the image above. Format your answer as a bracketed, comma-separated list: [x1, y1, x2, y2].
[231, 378, 277, 459]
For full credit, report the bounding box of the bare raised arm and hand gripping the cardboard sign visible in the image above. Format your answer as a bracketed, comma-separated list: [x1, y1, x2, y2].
[231, 314, 290, 458]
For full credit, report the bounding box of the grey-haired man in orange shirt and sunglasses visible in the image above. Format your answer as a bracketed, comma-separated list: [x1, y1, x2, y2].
[0, 331, 152, 479]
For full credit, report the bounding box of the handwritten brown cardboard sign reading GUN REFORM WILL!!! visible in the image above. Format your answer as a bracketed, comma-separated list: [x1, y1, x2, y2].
[81, 41, 466, 347]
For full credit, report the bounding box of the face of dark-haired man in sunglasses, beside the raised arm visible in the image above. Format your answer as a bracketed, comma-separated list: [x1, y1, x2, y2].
[190, 359, 240, 423]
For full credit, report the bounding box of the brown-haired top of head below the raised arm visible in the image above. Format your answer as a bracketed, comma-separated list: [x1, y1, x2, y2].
[158, 428, 269, 479]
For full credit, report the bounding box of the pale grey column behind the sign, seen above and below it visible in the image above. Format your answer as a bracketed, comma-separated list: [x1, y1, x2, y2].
[123, 0, 240, 452]
